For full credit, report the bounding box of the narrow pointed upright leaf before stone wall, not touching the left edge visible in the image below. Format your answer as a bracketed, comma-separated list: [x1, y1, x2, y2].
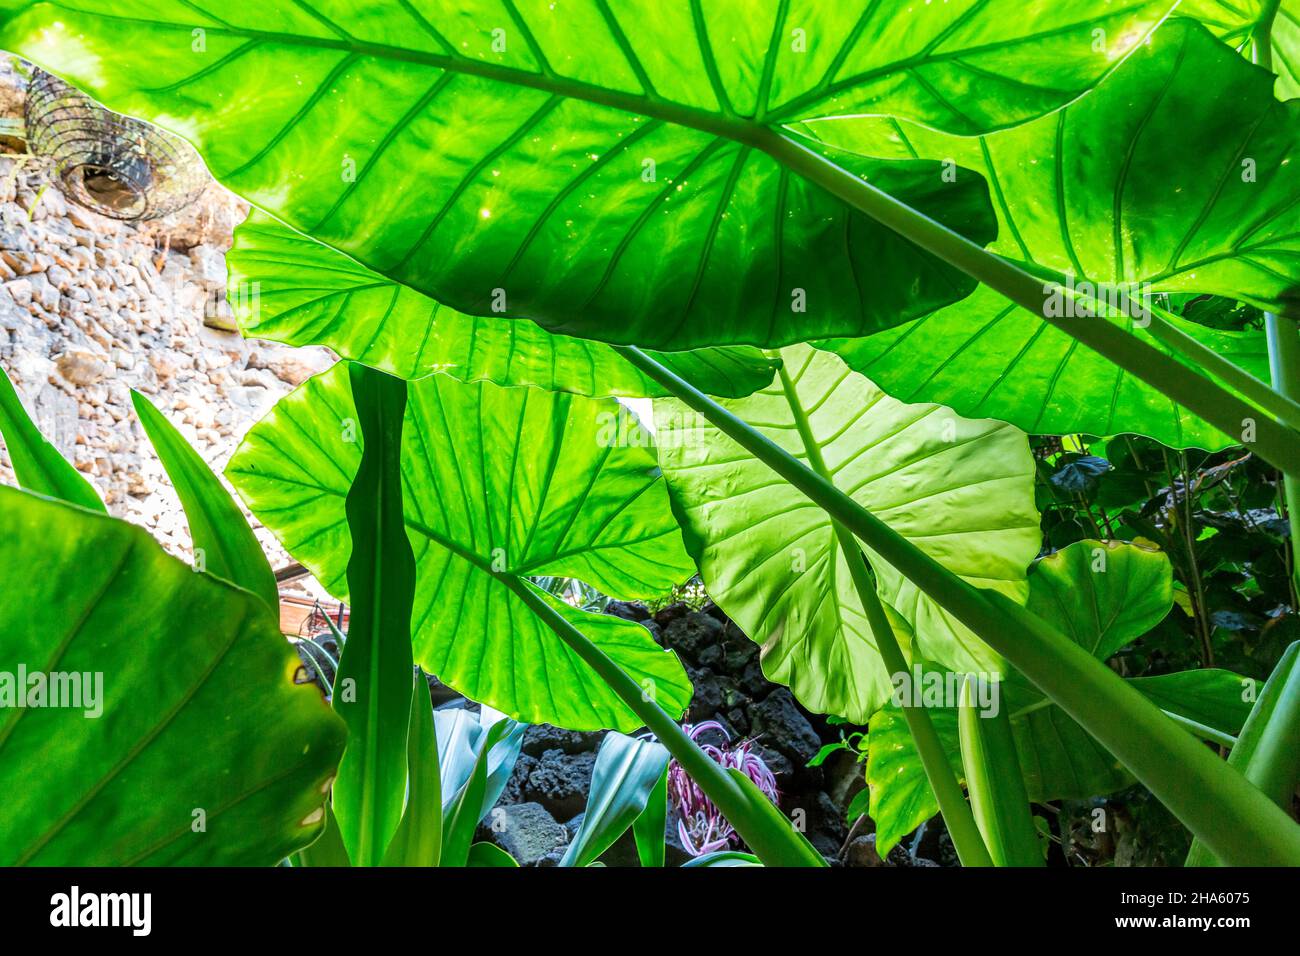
[131, 389, 280, 613]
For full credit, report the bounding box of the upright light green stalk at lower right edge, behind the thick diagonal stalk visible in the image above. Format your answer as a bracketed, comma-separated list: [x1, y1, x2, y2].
[1184, 641, 1300, 866]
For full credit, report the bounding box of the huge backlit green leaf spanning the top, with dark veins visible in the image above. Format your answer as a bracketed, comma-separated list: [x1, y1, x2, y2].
[0, 0, 1174, 349]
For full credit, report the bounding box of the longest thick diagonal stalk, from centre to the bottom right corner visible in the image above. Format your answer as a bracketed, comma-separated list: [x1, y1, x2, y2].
[618, 346, 1300, 866]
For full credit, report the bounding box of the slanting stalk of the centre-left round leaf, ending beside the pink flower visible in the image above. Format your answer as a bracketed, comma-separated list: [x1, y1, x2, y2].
[497, 574, 826, 866]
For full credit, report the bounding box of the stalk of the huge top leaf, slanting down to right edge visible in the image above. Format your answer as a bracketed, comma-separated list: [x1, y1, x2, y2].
[759, 133, 1300, 471]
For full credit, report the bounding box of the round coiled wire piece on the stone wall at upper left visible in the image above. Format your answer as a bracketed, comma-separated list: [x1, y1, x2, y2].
[25, 69, 208, 221]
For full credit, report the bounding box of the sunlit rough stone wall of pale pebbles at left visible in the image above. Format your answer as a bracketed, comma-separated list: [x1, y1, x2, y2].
[0, 66, 334, 567]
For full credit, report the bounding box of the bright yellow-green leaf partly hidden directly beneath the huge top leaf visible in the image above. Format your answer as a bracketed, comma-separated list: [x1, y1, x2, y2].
[226, 211, 776, 398]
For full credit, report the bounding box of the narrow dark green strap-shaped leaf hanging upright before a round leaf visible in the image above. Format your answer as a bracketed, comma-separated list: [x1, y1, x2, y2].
[333, 364, 416, 866]
